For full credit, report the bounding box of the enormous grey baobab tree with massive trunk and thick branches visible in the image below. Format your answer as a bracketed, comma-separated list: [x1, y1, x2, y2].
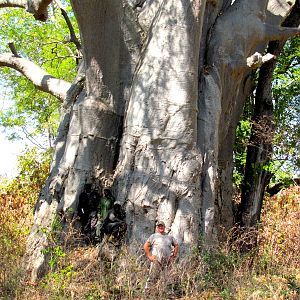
[0, 0, 299, 280]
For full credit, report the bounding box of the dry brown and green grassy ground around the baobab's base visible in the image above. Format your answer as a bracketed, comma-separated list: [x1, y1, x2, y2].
[0, 187, 300, 300]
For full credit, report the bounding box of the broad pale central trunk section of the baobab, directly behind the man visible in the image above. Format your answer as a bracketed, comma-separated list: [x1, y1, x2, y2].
[115, 0, 204, 253]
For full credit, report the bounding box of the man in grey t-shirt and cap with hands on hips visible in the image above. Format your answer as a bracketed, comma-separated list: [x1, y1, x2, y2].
[144, 221, 179, 291]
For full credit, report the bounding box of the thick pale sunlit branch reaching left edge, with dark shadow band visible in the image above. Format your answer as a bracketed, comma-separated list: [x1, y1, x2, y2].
[0, 53, 71, 102]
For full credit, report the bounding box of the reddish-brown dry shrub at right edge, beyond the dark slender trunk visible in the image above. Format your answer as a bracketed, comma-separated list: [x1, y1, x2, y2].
[259, 186, 300, 267]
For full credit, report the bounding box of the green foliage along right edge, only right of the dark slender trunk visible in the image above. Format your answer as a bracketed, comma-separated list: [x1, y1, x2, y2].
[273, 37, 300, 177]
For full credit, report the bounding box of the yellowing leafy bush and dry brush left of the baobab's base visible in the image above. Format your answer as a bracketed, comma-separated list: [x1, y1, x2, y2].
[0, 149, 49, 296]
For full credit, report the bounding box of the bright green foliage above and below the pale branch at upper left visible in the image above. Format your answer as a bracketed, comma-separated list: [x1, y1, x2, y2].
[0, 1, 78, 145]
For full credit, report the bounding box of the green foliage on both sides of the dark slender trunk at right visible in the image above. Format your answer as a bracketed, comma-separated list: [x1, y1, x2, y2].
[233, 37, 300, 189]
